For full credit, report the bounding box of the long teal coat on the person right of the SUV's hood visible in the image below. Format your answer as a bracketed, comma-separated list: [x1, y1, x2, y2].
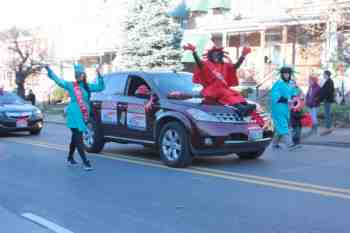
[271, 79, 293, 136]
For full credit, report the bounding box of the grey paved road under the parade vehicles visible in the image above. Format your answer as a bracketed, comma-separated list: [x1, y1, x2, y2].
[0, 124, 350, 233]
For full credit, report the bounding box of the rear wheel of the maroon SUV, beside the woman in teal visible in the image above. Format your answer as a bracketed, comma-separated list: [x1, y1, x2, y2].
[83, 121, 105, 153]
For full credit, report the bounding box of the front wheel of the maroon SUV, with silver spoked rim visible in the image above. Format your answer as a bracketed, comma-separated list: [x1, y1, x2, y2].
[158, 122, 192, 167]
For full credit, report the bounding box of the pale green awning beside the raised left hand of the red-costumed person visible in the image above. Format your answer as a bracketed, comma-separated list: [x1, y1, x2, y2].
[181, 34, 211, 63]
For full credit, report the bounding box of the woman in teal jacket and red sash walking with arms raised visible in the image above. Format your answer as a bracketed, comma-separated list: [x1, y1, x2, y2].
[45, 64, 105, 170]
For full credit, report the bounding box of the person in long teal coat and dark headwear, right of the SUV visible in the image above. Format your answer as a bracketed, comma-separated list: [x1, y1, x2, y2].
[271, 67, 294, 149]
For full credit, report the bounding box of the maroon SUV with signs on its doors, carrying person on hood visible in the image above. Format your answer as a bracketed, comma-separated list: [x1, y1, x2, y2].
[84, 72, 273, 167]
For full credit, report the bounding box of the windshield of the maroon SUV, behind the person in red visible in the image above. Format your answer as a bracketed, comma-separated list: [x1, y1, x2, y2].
[153, 73, 202, 97]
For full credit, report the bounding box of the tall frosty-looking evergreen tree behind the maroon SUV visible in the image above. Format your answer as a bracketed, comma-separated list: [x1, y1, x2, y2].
[114, 0, 182, 70]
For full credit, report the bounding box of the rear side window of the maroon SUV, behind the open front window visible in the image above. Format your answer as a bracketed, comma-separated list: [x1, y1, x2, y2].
[103, 74, 127, 95]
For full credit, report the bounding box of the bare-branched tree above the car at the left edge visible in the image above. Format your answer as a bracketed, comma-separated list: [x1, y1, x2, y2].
[0, 27, 47, 98]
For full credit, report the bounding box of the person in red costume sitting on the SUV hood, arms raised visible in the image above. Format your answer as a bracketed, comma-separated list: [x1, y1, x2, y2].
[184, 44, 264, 127]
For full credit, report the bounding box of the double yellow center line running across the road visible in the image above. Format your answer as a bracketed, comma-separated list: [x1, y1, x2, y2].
[4, 139, 350, 199]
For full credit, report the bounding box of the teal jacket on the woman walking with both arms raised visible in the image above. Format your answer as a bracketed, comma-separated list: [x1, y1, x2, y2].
[47, 67, 105, 132]
